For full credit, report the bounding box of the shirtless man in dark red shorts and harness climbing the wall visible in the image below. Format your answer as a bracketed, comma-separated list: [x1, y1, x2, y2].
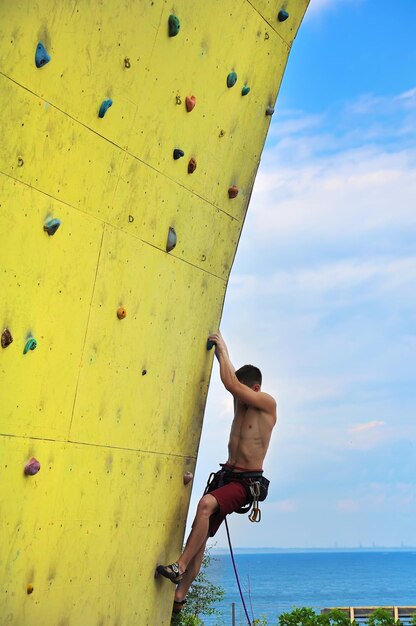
[157, 332, 277, 613]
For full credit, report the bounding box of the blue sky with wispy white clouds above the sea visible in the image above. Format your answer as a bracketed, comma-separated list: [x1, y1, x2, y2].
[190, 0, 416, 547]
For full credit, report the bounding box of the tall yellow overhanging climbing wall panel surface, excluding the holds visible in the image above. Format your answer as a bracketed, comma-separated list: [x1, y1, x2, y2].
[0, 0, 308, 626]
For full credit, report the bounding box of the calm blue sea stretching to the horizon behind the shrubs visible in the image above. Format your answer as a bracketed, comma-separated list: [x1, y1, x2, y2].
[200, 548, 416, 626]
